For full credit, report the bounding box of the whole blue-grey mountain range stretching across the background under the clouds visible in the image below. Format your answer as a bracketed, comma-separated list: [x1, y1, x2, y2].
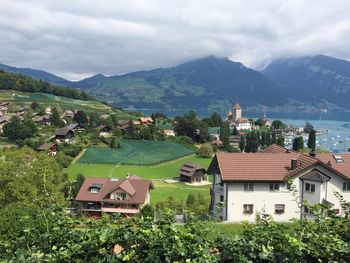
[0, 55, 350, 111]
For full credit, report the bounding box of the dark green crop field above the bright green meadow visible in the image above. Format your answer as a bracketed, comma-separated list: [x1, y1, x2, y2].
[79, 140, 193, 165]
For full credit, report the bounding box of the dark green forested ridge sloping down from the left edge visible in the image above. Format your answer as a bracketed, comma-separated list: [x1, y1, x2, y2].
[0, 70, 94, 100]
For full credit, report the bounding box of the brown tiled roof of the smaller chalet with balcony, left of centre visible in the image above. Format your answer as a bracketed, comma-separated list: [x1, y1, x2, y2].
[75, 178, 153, 204]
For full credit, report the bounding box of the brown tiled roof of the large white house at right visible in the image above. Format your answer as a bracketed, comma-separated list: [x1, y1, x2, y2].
[208, 150, 350, 181]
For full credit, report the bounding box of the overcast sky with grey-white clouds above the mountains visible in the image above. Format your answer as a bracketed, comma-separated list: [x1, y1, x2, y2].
[0, 0, 350, 80]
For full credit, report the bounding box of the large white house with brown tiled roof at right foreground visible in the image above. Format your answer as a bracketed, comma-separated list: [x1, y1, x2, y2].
[208, 145, 350, 222]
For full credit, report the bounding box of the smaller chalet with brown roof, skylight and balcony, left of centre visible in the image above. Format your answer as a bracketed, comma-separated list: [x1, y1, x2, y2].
[75, 176, 154, 217]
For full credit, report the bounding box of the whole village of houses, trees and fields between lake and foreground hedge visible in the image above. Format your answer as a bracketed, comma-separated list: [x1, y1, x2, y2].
[0, 96, 350, 222]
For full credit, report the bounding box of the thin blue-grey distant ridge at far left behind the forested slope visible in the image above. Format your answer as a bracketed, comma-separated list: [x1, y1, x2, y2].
[0, 64, 72, 86]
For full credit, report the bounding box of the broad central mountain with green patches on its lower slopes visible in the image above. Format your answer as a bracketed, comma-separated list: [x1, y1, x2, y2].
[76, 57, 287, 110]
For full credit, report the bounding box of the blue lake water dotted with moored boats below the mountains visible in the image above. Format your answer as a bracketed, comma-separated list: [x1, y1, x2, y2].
[139, 110, 350, 152]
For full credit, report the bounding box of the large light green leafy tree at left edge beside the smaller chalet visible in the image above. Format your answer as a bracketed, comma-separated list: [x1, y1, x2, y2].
[0, 148, 64, 208]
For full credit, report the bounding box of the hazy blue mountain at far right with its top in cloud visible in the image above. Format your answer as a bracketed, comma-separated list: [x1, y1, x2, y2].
[261, 55, 350, 109]
